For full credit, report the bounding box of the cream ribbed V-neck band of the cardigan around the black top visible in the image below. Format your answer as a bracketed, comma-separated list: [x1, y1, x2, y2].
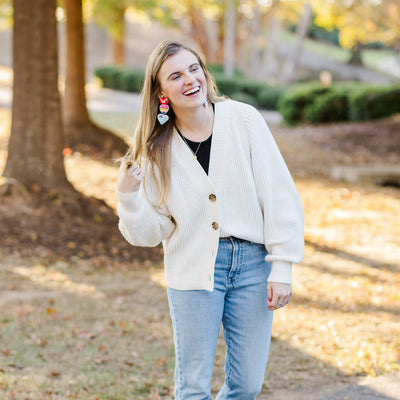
[171, 101, 229, 192]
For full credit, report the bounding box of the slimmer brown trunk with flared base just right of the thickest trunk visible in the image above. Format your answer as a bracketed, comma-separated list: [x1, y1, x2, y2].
[63, 0, 127, 153]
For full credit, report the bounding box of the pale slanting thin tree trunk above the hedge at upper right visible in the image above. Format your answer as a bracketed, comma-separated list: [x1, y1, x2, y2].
[282, 3, 312, 83]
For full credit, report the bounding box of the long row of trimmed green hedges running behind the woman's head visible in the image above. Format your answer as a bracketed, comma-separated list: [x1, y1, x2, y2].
[95, 66, 400, 125]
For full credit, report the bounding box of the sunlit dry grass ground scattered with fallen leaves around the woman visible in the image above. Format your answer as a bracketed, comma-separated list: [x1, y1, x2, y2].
[0, 110, 400, 400]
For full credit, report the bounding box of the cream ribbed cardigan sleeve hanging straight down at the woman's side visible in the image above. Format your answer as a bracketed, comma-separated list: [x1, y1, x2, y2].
[243, 106, 304, 283]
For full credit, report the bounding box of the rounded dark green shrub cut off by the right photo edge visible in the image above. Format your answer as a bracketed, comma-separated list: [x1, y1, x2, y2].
[349, 85, 400, 121]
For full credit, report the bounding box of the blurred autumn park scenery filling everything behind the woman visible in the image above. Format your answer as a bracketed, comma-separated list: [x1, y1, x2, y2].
[0, 0, 400, 400]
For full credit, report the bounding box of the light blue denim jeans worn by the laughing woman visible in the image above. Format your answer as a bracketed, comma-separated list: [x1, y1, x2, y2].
[167, 238, 273, 400]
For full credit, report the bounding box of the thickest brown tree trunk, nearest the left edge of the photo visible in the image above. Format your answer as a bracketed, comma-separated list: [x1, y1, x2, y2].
[4, 0, 72, 190]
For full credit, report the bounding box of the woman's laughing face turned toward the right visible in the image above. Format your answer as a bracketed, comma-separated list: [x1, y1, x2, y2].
[158, 49, 207, 114]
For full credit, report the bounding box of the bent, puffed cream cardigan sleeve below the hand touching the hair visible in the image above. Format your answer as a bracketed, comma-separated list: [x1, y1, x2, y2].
[117, 185, 175, 247]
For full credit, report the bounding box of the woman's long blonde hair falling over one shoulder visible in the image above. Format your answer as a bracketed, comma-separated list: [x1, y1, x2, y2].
[126, 40, 223, 206]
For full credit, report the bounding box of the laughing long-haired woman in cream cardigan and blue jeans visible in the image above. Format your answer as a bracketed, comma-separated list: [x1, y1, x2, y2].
[117, 41, 304, 400]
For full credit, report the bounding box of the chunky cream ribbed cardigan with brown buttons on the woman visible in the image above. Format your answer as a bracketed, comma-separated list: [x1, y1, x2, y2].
[117, 100, 304, 291]
